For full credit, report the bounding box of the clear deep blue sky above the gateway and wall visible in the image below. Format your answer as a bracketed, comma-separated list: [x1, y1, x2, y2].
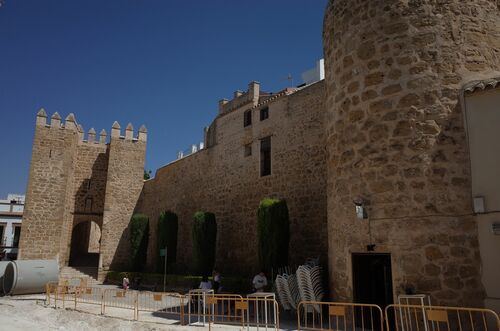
[0, 0, 326, 199]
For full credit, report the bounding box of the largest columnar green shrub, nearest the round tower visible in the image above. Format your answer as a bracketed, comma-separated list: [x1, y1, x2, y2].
[257, 198, 290, 271]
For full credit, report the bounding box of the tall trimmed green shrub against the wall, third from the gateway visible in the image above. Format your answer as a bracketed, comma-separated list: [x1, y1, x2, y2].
[191, 211, 217, 276]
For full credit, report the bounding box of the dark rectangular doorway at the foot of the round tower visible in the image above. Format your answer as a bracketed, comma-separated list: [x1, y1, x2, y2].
[352, 253, 393, 309]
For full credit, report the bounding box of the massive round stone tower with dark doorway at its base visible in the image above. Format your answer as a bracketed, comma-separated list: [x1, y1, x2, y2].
[323, 0, 500, 305]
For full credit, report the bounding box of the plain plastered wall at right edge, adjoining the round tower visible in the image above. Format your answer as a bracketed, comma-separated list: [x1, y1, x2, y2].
[465, 88, 500, 312]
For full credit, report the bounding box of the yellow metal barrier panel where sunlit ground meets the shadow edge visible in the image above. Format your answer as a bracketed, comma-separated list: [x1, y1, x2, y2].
[137, 292, 186, 325]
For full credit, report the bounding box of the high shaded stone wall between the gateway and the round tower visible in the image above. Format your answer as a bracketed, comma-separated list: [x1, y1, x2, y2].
[137, 82, 327, 274]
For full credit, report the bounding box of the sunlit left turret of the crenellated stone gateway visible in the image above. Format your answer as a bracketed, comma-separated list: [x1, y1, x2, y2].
[19, 110, 78, 261]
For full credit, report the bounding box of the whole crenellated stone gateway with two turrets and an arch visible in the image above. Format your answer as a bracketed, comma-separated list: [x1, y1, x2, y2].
[19, 109, 147, 279]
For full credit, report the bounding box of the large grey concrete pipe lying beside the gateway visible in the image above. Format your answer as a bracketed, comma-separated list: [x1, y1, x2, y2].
[3, 260, 59, 295]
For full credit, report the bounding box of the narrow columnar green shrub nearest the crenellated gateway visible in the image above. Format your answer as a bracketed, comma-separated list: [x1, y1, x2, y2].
[130, 214, 149, 271]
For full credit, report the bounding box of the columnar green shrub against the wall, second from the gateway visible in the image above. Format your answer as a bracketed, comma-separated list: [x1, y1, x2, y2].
[157, 211, 179, 271]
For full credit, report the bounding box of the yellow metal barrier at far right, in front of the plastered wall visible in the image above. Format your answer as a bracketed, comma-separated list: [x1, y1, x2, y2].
[385, 304, 500, 331]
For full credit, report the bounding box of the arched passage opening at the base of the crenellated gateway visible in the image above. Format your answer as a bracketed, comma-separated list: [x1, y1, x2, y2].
[69, 221, 101, 267]
